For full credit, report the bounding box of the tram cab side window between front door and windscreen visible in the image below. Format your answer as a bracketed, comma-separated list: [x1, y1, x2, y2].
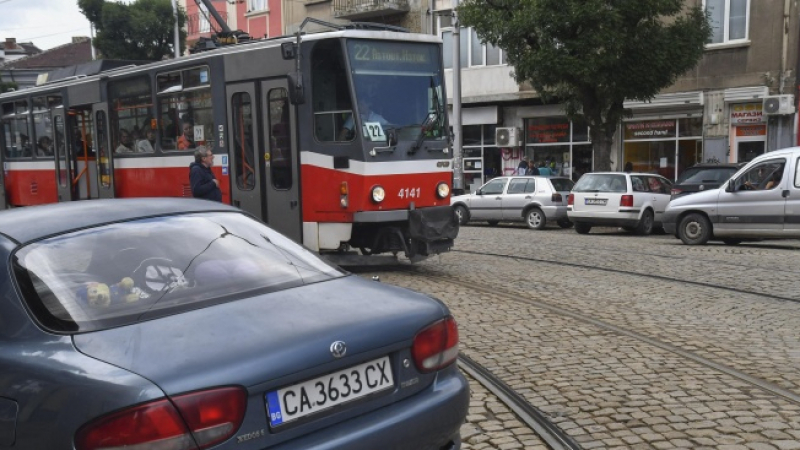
[311, 40, 355, 142]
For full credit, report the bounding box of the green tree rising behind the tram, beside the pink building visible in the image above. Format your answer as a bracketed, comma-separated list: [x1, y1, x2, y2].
[78, 0, 186, 61]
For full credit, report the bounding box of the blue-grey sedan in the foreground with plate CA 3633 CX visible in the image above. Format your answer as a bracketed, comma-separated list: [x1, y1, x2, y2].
[0, 198, 469, 450]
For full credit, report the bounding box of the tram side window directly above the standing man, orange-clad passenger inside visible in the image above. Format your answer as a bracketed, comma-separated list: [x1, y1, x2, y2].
[157, 66, 214, 151]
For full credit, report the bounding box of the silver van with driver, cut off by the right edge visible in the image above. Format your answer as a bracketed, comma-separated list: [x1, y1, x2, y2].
[663, 147, 800, 245]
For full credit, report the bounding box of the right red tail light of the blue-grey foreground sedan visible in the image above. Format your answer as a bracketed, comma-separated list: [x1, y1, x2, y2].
[411, 316, 458, 373]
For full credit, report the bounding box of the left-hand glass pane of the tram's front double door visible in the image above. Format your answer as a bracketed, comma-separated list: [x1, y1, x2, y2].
[231, 92, 256, 191]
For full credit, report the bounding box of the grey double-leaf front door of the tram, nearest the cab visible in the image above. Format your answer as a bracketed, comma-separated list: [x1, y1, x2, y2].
[227, 80, 302, 242]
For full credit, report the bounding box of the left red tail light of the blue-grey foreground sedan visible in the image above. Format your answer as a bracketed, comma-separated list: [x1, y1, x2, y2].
[75, 387, 247, 450]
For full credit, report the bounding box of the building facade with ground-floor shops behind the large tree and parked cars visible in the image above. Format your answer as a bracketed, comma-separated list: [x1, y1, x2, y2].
[434, 0, 800, 190]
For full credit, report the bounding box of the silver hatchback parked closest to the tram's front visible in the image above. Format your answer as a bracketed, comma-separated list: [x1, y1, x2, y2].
[450, 176, 575, 230]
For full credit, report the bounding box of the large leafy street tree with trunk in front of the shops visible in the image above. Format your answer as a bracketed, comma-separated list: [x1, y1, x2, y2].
[458, 0, 711, 170]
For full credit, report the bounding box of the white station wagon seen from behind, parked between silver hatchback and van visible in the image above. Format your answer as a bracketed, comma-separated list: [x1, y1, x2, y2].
[567, 172, 672, 235]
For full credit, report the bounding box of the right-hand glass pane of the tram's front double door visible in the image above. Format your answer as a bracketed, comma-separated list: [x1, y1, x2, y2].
[269, 88, 292, 189]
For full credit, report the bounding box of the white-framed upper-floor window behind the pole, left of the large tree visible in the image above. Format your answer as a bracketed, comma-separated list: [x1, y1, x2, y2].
[437, 12, 506, 69]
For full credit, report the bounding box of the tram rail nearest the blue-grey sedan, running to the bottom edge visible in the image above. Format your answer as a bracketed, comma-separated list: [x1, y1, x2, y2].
[458, 354, 581, 450]
